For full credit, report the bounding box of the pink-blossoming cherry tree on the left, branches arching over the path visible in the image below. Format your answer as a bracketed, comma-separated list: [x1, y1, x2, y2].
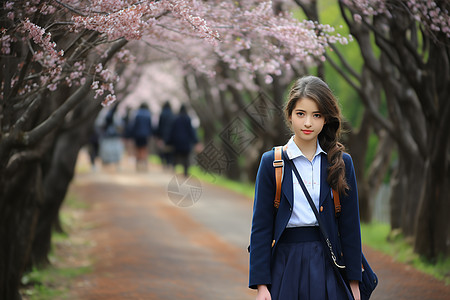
[0, 0, 347, 299]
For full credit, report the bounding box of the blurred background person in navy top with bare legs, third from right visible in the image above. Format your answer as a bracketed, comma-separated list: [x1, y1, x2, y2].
[132, 103, 153, 172]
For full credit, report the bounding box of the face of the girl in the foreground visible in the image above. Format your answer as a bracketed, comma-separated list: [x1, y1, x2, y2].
[289, 98, 325, 143]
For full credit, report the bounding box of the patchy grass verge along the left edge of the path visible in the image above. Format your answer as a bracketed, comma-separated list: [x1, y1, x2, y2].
[21, 194, 92, 300]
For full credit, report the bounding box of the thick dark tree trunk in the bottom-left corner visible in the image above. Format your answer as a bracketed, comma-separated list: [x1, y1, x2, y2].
[0, 161, 41, 300]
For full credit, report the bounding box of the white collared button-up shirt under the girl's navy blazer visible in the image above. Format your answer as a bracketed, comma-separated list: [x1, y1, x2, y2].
[286, 137, 326, 227]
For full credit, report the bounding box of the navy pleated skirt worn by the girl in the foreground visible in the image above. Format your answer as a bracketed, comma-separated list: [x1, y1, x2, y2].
[270, 226, 353, 300]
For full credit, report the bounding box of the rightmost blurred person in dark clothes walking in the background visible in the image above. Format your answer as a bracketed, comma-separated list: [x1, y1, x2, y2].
[168, 104, 198, 177]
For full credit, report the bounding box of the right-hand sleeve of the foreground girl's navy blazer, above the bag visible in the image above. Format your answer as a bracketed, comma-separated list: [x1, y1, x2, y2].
[339, 153, 362, 281]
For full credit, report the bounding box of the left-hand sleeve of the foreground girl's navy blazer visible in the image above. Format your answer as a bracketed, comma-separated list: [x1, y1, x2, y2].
[249, 150, 276, 289]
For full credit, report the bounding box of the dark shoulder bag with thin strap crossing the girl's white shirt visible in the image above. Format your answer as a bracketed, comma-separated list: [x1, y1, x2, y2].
[283, 153, 378, 300]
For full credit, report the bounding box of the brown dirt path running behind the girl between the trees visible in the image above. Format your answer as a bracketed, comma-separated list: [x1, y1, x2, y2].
[70, 154, 450, 300]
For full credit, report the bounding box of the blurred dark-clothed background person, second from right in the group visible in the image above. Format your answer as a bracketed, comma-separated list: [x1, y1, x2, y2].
[156, 101, 175, 168]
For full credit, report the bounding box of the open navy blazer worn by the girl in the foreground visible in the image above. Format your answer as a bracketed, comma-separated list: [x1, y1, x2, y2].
[249, 149, 362, 289]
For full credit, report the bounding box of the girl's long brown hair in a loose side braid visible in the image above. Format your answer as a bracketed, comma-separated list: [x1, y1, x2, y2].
[284, 76, 349, 193]
